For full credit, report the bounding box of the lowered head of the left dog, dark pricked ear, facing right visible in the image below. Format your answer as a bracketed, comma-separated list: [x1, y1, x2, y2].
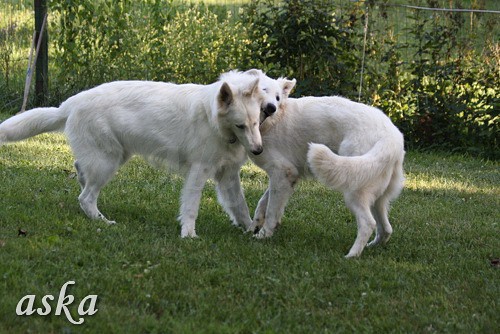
[216, 71, 265, 155]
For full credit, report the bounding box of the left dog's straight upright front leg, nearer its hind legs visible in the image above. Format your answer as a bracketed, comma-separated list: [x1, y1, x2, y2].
[179, 164, 212, 238]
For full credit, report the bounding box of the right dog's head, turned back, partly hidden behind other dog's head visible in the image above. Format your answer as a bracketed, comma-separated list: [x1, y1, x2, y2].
[244, 69, 297, 124]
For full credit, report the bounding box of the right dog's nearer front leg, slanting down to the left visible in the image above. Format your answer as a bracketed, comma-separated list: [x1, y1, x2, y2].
[255, 166, 299, 239]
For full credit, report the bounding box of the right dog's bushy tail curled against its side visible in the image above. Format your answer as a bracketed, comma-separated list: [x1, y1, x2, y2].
[307, 139, 404, 191]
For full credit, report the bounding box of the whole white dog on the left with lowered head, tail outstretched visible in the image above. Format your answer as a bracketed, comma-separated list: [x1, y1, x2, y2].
[0, 72, 266, 237]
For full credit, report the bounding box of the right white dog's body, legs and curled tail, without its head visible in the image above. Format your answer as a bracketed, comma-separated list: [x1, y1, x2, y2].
[250, 87, 405, 257]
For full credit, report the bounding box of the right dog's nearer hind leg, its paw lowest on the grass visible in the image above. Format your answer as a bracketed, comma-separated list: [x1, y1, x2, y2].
[344, 192, 376, 258]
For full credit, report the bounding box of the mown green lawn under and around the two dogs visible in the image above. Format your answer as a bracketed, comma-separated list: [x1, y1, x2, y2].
[0, 129, 500, 333]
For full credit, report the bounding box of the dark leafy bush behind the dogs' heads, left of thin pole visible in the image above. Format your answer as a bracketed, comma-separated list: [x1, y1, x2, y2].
[244, 0, 358, 96]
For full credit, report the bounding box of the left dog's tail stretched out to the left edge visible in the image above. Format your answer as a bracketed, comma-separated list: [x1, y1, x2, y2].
[0, 108, 69, 146]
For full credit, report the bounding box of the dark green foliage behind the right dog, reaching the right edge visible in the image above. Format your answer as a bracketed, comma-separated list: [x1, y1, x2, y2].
[240, 0, 500, 159]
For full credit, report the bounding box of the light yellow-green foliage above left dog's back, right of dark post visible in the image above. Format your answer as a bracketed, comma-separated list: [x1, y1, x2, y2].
[50, 0, 249, 95]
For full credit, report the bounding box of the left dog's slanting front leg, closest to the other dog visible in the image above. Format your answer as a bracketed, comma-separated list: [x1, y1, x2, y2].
[215, 166, 252, 231]
